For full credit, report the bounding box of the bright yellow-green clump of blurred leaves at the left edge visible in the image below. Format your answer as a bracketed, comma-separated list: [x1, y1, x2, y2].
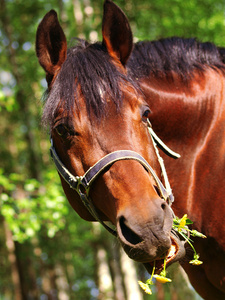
[0, 171, 68, 243]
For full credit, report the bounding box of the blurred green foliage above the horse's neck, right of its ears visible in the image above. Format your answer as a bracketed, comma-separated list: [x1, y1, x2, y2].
[117, 0, 225, 46]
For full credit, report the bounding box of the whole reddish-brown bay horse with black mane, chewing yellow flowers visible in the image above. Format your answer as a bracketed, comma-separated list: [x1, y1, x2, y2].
[36, 0, 225, 300]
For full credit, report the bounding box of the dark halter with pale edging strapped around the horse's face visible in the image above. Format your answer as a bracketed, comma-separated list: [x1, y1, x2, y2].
[50, 120, 180, 236]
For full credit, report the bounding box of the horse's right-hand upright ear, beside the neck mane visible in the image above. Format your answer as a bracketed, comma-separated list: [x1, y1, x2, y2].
[102, 0, 133, 65]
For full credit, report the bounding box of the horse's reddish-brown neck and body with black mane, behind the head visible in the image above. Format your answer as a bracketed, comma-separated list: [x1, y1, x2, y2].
[127, 28, 225, 300]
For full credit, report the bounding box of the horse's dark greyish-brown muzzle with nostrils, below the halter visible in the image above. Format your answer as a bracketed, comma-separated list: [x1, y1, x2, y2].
[117, 199, 181, 263]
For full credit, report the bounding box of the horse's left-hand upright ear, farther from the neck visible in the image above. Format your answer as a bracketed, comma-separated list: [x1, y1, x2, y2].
[36, 10, 67, 85]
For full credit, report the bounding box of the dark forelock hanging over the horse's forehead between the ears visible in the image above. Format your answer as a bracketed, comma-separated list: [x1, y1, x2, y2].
[42, 39, 135, 126]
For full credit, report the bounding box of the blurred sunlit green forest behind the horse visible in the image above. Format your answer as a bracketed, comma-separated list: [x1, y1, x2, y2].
[0, 0, 225, 300]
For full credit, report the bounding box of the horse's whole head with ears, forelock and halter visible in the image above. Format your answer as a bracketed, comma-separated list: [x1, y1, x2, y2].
[36, 0, 184, 271]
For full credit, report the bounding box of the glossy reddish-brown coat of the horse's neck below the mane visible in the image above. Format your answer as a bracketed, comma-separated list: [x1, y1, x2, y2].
[142, 70, 225, 231]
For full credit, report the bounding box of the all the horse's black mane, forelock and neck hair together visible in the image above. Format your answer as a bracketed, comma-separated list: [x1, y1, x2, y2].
[43, 37, 225, 126]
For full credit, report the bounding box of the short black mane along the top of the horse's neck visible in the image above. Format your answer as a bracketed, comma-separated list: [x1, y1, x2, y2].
[128, 37, 225, 80]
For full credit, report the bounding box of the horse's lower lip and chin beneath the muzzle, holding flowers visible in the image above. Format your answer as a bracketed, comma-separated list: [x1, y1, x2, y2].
[144, 233, 186, 274]
